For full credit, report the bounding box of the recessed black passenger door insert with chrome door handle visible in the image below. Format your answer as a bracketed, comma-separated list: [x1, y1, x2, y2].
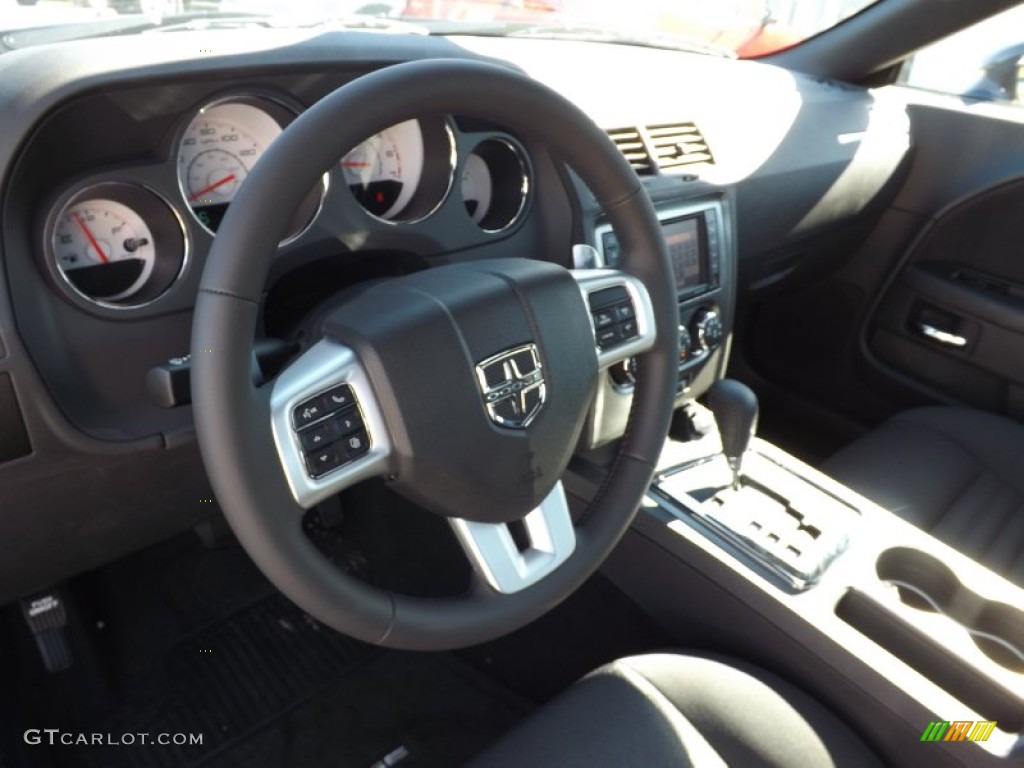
[867, 174, 1024, 417]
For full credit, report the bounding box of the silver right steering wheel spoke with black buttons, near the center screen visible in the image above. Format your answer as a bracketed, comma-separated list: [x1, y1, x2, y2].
[572, 269, 657, 370]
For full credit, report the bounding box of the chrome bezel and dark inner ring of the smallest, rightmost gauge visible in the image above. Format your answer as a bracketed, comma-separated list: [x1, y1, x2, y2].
[459, 134, 534, 234]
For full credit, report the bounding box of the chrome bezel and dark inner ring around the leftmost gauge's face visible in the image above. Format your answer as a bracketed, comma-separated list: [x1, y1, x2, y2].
[42, 179, 191, 312]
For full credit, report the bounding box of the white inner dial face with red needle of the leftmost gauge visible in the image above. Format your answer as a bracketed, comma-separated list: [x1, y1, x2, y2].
[52, 200, 156, 302]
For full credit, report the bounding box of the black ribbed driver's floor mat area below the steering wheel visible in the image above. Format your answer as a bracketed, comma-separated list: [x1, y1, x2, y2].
[61, 595, 378, 768]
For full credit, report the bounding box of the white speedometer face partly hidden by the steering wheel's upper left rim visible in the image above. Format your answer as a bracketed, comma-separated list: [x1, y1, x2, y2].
[178, 101, 281, 231]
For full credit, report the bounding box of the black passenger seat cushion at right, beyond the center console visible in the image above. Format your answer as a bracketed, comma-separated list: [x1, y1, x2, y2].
[821, 407, 1024, 586]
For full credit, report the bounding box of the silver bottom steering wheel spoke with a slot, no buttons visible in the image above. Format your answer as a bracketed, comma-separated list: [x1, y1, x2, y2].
[451, 482, 575, 594]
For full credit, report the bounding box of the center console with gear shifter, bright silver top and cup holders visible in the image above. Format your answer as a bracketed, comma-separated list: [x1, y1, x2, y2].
[566, 390, 1024, 766]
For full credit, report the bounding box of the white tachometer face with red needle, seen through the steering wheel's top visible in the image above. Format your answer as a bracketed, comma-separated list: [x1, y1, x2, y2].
[341, 120, 424, 220]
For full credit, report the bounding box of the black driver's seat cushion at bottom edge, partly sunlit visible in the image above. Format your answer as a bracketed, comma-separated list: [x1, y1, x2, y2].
[471, 653, 882, 768]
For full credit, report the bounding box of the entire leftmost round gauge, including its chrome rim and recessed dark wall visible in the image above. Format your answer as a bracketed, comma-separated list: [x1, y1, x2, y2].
[44, 181, 187, 309]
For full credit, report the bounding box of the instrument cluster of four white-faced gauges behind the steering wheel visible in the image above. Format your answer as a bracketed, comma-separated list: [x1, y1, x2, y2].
[40, 93, 531, 310]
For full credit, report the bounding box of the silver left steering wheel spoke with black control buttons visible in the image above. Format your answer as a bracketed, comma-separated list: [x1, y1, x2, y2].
[270, 340, 391, 509]
